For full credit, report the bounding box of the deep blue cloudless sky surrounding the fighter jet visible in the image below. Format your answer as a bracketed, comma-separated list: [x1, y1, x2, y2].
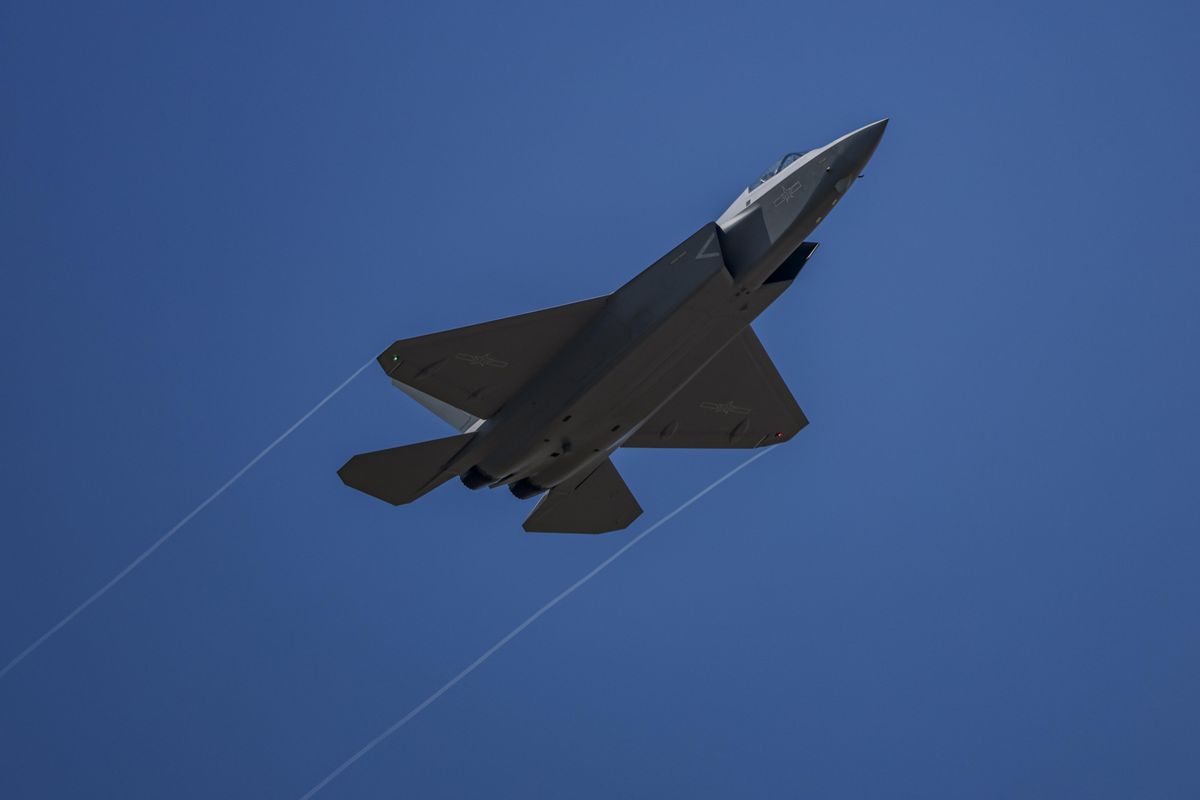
[0, 1, 1200, 798]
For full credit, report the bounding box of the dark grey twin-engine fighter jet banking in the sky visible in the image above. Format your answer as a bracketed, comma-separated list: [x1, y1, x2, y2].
[338, 119, 888, 534]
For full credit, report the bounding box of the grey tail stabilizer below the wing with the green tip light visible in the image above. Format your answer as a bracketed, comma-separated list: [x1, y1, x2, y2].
[337, 433, 475, 505]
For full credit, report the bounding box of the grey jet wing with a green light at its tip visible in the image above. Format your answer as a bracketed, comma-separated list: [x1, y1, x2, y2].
[378, 297, 607, 419]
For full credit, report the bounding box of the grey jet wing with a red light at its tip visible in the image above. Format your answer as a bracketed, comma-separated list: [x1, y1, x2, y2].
[623, 326, 809, 447]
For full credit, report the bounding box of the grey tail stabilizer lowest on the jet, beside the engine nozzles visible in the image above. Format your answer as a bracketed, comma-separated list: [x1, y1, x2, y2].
[523, 458, 642, 534]
